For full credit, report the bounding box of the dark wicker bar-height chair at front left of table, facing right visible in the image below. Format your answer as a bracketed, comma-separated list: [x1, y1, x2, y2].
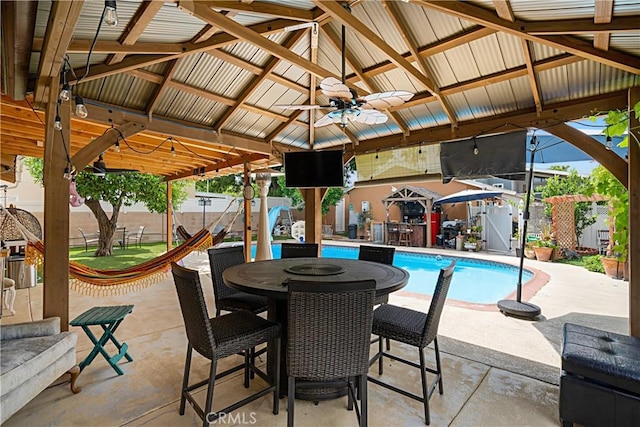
[171, 263, 280, 427]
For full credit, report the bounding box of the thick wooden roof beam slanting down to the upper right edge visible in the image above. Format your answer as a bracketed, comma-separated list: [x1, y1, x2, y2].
[412, 0, 640, 74]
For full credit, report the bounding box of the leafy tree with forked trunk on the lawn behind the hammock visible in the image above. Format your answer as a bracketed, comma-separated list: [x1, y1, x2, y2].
[25, 157, 187, 257]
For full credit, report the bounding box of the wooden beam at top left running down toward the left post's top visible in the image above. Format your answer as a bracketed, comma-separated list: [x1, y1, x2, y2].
[34, 0, 84, 108]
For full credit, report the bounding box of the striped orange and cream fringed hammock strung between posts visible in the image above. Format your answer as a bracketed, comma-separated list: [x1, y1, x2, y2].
[25, 229, 221, 296]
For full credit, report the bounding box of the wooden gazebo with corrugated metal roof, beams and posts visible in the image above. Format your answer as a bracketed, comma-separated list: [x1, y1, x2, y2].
[0, 0, 640, 336]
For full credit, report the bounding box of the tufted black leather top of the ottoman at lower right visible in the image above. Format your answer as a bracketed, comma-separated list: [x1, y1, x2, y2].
[562, 323, 640, 395]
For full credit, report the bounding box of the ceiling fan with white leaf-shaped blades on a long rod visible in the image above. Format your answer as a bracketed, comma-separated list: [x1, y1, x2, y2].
[276, 15, 413, 128]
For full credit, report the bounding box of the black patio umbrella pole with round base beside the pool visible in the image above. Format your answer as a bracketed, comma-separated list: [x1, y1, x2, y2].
[498, 134, 541, 319]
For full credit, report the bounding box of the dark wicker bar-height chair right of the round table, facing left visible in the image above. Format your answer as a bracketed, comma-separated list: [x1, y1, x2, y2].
[369, 261, 456, 424]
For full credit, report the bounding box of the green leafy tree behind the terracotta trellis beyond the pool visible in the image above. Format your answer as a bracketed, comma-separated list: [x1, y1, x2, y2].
[536, 169, 596, 246]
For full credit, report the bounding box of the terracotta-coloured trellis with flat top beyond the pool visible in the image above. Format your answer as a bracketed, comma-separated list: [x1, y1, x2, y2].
[544, 194, 609, 250]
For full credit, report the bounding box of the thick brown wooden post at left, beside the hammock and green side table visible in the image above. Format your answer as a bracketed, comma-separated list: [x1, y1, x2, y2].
[42, 76, 71, 331]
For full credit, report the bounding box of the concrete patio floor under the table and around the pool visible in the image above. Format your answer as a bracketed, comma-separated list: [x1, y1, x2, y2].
[0, 242, 628, 427]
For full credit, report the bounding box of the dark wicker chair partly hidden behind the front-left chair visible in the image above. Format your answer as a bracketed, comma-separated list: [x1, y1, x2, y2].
[207, 246, 267, 316]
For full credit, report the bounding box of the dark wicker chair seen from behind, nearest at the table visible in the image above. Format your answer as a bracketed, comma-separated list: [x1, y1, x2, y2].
[287, 280, 376, 427]
